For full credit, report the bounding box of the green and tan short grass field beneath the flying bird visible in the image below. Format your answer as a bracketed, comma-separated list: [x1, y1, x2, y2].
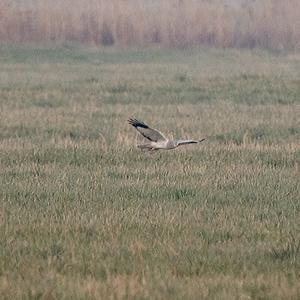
[0, 45, 300, 299]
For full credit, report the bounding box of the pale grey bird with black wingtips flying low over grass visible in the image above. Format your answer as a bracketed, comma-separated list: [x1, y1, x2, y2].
[128, 118, 205, 151]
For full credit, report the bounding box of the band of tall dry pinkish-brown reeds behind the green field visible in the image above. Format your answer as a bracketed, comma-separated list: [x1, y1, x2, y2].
[0, 0, 300, 49]
